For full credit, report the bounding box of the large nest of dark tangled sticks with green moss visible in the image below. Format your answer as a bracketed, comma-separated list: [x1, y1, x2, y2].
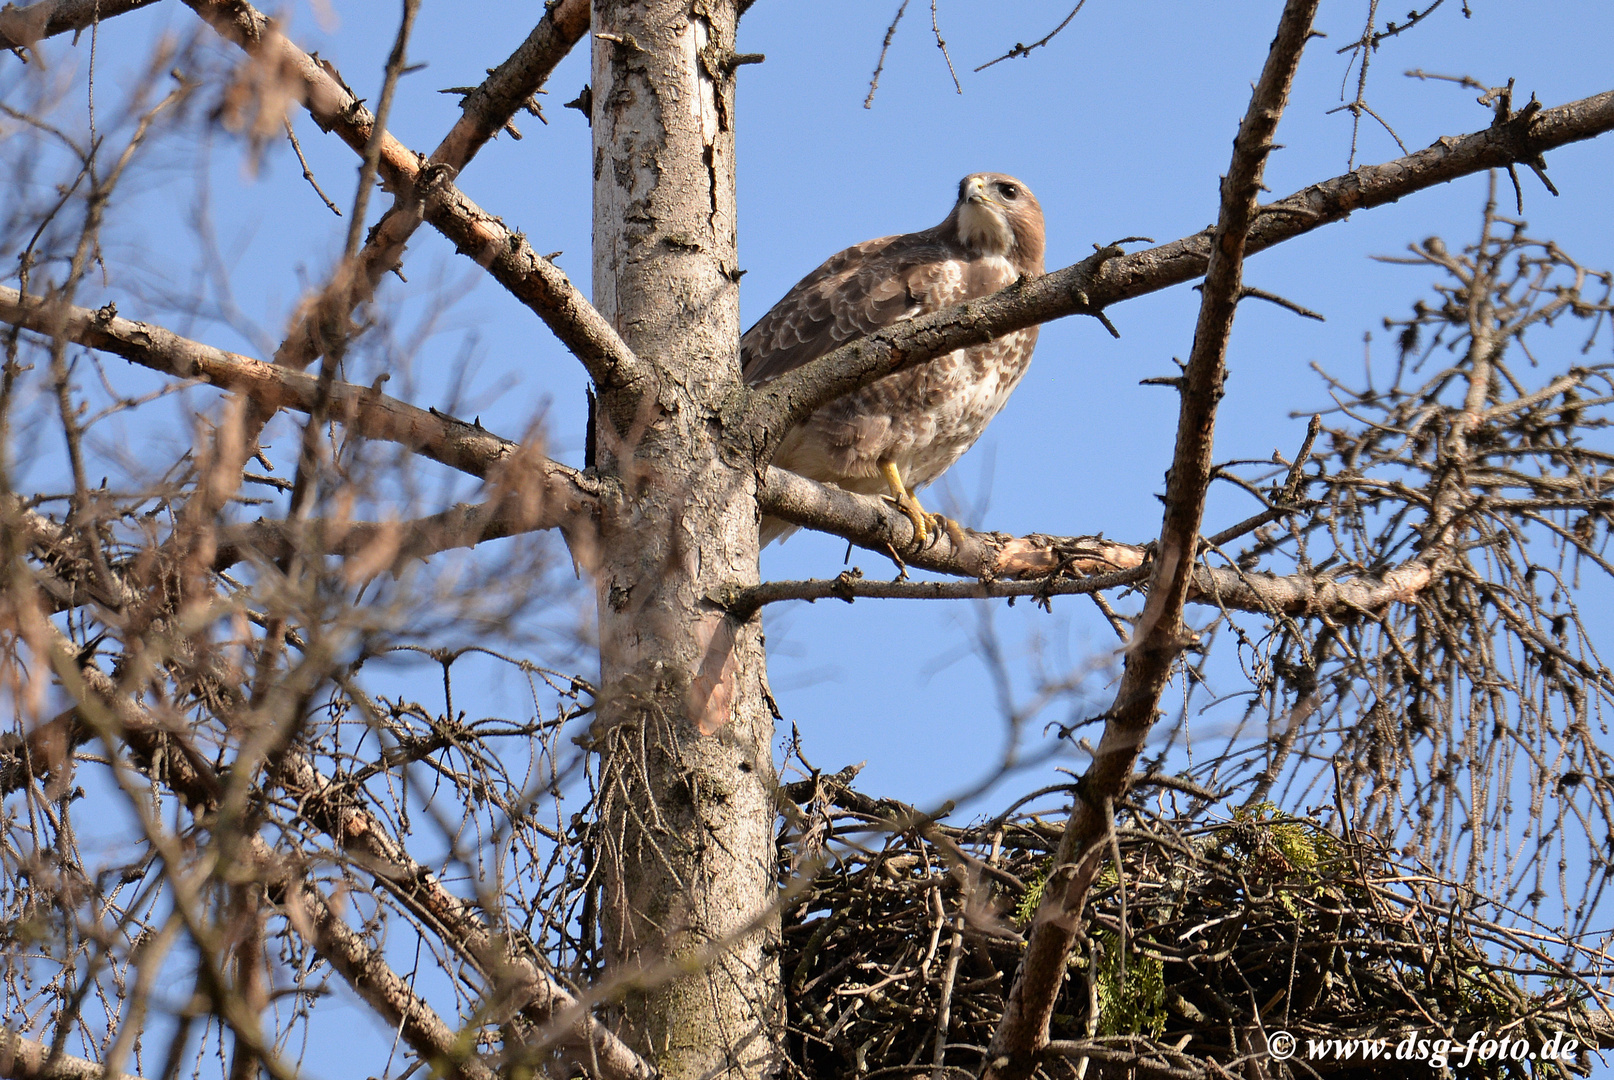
[781, 772, 1614, 1080]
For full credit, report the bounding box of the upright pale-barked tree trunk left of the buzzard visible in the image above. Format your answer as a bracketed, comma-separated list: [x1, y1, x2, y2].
[591, 0, 783, 1078]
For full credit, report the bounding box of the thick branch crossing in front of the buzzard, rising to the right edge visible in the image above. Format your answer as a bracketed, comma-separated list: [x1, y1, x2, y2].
[751, 83, 1614, 446]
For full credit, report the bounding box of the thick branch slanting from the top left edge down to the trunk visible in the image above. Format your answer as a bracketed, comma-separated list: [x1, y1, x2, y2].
[186, 0, 646, 393]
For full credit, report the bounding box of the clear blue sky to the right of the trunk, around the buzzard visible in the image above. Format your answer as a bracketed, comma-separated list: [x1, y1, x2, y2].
[739, 0, 1614, 797]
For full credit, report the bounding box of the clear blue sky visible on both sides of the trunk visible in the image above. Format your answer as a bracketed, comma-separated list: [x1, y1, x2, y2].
[6, 0, 1614, 1077]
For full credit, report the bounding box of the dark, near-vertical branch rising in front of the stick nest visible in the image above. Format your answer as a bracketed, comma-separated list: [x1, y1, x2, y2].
[983, 0, 1319, 1080]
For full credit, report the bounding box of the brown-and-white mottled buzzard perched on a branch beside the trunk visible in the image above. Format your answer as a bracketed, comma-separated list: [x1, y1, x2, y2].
[739, 173, 1043, 544]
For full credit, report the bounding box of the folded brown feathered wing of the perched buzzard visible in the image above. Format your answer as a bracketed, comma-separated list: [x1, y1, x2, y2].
[739, 232, 967, 386]
